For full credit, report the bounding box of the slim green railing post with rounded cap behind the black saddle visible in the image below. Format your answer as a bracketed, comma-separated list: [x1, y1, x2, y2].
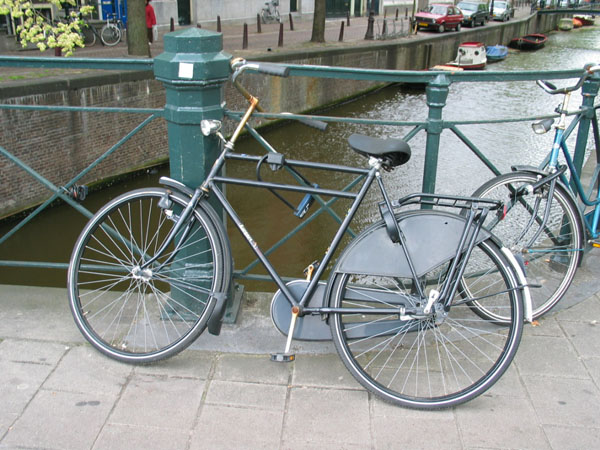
[422, 75, 450, 194]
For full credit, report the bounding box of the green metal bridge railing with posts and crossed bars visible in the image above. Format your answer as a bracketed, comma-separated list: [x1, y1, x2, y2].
[0, 29, 600, 284]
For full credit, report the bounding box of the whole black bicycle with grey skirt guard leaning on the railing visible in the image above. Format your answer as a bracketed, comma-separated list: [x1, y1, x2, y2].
[68, 59, 529, 409]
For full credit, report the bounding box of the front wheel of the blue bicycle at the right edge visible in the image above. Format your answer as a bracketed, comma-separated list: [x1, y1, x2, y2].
[473, 172, 584, 321]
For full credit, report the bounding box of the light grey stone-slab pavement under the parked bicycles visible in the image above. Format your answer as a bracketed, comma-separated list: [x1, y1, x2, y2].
[0, 243, 600, 450]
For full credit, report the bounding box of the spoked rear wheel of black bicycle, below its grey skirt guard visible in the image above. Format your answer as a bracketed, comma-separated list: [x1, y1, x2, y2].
[328, 225, 524, 409]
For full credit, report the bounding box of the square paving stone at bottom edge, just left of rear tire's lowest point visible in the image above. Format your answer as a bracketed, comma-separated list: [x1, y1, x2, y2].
[283, 387, 371, 448]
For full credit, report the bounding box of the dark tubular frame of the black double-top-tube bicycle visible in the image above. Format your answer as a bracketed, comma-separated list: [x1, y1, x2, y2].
[158, 97, 498, 326]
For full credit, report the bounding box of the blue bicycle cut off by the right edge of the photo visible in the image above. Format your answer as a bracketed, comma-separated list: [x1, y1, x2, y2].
[473, 65, 600, 320]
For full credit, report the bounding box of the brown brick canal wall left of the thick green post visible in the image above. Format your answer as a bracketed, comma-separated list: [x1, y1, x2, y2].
[0, 80, 168, 217]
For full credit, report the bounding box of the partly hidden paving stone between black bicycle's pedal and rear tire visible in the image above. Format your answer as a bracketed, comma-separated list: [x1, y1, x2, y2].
[292, 354, 363, 389]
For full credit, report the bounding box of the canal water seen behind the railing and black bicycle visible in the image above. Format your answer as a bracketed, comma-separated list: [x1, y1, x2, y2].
[0, 27, 600, 290]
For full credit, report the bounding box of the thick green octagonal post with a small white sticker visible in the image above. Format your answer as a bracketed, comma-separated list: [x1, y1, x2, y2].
[154, 28, 231, 312]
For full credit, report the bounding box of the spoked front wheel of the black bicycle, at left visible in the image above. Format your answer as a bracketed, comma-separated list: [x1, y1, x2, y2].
[68, 188, 232, 363]
